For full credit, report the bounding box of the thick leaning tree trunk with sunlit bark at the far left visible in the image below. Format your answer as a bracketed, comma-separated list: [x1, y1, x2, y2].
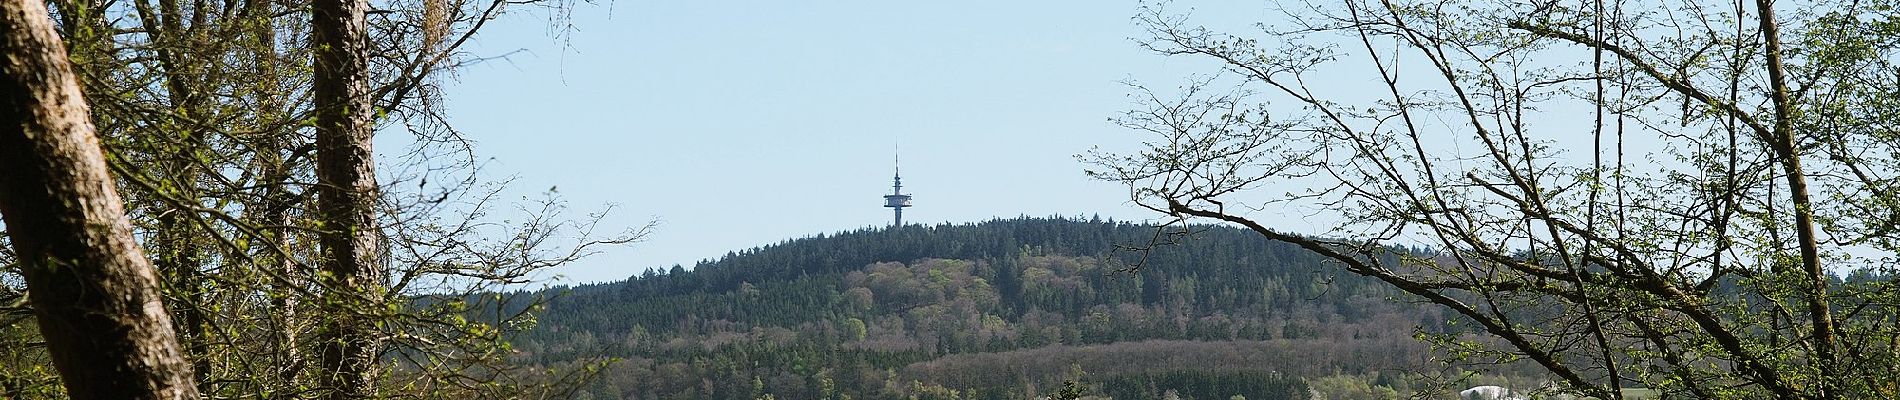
[0, 0, 198, 400]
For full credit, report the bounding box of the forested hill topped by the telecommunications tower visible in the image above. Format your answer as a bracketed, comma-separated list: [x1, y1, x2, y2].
[519, 218, 1474, 398]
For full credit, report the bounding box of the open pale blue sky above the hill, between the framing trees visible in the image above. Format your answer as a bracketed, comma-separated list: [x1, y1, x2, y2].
[437, 0, 1271, 282]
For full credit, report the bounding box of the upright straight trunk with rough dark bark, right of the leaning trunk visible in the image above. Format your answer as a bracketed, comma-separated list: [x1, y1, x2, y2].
[310, 0, 382, 400]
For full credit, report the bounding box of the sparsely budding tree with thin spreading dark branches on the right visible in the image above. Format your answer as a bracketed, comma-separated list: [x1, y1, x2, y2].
[1087, 0, 1900, 398]
